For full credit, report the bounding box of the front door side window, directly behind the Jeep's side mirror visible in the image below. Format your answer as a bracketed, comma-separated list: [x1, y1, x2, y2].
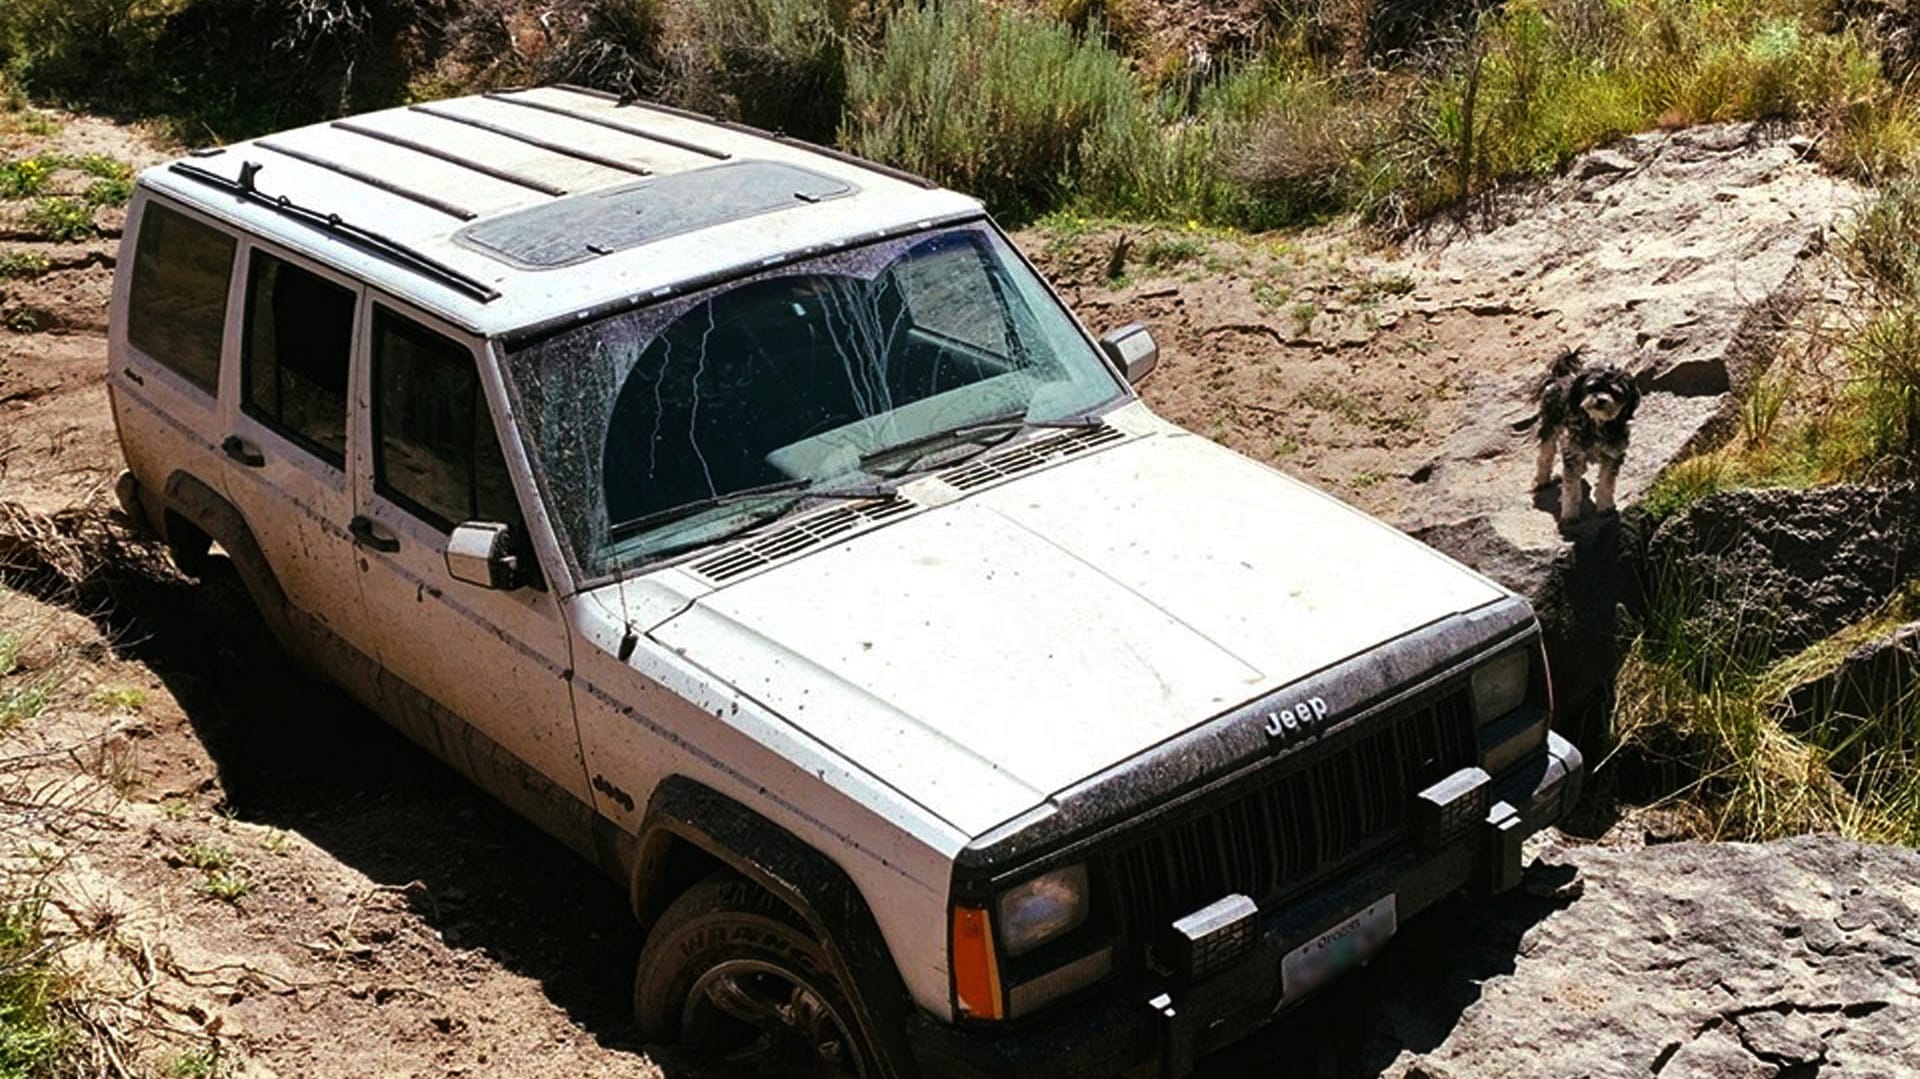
[372, 307, 524, 536]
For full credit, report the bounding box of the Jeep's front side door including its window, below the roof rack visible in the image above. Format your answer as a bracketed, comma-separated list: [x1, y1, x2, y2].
[353, 301, 591, 803]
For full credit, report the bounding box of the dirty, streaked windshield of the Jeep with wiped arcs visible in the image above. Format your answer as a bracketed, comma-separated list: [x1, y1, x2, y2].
[507, 225, 1121, 580]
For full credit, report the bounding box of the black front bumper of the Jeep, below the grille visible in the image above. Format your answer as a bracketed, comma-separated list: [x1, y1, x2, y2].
[908, 733, 1584, 1079]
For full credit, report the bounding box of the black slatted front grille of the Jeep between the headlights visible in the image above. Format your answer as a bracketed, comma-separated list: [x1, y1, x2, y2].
[1106, 689, 1476, 954]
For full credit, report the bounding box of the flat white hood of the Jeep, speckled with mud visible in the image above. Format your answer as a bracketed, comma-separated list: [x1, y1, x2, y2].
[651, 434, 1505, 835]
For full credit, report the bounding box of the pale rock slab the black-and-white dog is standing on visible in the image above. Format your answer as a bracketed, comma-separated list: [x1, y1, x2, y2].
[1396, 125, 1860, 749]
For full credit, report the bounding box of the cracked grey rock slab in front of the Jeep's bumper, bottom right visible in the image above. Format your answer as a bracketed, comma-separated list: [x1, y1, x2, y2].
[1204, 835, 1920, 1079]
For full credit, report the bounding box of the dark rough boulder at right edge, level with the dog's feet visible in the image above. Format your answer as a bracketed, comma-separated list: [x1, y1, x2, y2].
[1645, 484, 1920, 660]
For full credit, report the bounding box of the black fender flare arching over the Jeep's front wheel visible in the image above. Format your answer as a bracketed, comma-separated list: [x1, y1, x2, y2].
[630, 776, 918, 1079]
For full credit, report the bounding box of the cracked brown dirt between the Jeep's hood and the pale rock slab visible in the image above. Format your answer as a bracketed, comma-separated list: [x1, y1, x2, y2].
[1020, 216, 1536, 520]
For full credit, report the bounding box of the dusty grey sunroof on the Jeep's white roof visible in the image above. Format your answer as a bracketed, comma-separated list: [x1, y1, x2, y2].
[455, 161, 854, 269]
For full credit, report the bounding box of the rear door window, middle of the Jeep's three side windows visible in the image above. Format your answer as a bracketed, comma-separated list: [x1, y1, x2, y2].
[240, 252, 353, 467]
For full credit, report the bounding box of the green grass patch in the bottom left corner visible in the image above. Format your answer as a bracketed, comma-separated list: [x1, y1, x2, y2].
[0, 893, 79, 1079]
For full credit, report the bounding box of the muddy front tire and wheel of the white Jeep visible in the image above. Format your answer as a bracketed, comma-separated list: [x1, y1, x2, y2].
[634, 874, 876, 1079]
